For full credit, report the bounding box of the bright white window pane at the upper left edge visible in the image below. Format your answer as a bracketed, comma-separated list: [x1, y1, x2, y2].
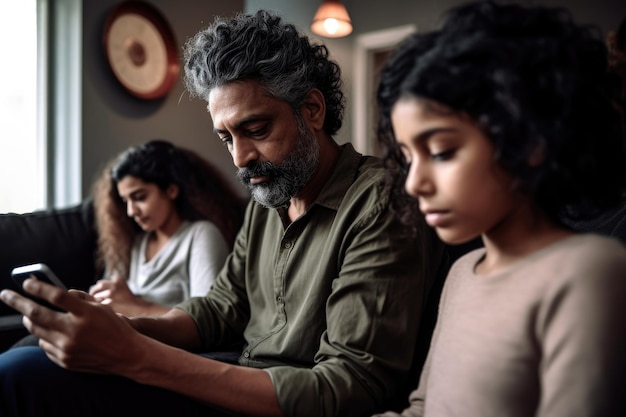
[0, 0, 46, 213]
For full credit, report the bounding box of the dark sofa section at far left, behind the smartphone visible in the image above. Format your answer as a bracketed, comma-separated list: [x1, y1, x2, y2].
[0, 200, 99, 352]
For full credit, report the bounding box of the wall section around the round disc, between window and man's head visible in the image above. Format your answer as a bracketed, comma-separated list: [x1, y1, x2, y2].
[82, 0, 243, 197]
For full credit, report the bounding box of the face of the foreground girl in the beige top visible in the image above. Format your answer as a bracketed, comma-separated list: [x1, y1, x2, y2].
[391, 97, 515, 243]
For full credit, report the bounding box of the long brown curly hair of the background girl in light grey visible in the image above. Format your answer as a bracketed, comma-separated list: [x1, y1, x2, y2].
[92, 140, 246, 277]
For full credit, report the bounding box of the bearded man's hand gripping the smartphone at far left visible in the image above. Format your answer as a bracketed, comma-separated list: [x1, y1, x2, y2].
[0, 278, 144, 374]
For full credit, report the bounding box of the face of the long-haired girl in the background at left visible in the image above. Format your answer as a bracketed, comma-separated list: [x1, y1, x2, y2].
[117, 175, 178, 232]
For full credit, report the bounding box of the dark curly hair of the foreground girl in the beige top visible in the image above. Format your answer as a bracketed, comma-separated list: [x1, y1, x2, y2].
[377, 1, 626, 231]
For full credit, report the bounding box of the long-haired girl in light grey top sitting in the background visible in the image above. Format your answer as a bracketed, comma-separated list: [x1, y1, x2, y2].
[90, 140, 244, 316]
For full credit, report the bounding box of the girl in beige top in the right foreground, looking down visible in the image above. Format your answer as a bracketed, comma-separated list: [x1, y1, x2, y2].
[378, 2, 626, 417]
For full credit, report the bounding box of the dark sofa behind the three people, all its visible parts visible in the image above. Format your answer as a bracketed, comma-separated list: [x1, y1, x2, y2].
[0, 196, 626, 354]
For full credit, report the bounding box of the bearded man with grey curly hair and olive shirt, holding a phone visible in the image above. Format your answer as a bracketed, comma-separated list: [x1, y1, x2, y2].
[0, 11, 441, 417]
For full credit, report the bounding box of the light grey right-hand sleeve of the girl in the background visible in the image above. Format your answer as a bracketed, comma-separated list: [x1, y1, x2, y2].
[189, 221, 229, 297]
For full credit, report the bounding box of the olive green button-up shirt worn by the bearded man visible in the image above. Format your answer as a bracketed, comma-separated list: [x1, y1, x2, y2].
[178, 144, 440, 417]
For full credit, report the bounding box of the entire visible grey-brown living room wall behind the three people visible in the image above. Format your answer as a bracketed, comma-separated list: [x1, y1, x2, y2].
[82, 0, 626, 202]
